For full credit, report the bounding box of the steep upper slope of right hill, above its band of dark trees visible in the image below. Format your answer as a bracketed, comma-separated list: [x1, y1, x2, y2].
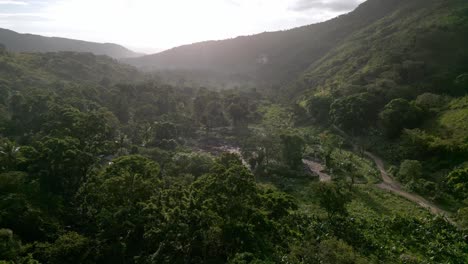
[296, 0, 468, 99]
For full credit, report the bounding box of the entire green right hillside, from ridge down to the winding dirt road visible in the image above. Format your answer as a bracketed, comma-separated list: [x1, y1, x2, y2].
[287, 0, 468, 212]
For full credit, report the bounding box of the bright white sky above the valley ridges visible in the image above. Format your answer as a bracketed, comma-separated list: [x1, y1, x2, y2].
[0, 0, 364, 53]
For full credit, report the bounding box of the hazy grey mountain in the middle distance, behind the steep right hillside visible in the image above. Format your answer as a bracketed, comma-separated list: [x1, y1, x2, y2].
[126, 0, 407, 83]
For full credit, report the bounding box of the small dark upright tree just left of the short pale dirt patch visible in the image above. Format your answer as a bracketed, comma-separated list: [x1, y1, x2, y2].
[280, 135, 305, 169]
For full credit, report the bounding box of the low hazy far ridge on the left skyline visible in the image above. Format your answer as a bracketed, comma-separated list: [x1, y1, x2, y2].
[0, 28, 142, 59]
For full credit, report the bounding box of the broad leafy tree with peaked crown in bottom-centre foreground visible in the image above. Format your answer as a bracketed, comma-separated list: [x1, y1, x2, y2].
[142, 154, 297, 263]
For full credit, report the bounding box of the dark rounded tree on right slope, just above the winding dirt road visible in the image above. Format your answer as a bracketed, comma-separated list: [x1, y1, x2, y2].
[379, 98, 423, 138]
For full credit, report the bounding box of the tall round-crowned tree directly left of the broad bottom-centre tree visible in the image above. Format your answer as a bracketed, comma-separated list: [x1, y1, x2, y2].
[78, 155, 162, 263]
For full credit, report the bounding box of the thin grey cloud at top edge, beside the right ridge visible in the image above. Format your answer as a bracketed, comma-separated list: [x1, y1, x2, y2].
[290, 0, 362, 12]
